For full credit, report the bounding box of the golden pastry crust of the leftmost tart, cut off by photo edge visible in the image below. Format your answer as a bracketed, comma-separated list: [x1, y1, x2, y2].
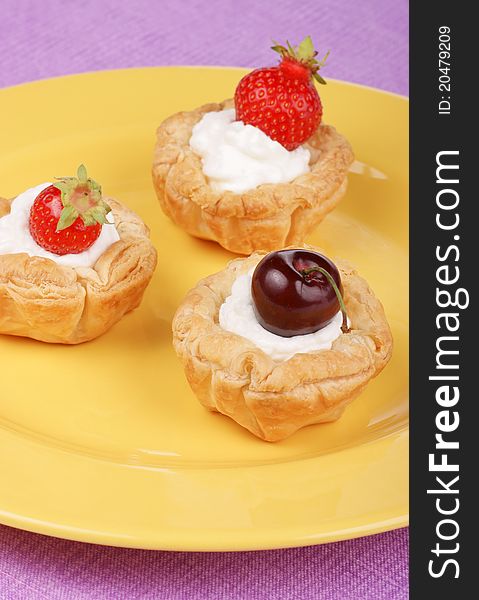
[0, 198, 156, 344]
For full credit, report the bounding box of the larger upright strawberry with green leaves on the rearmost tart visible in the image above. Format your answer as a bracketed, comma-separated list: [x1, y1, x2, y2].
[235, 35, 329, 150]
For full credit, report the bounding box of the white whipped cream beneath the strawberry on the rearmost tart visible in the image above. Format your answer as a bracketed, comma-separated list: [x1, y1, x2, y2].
[190, 109, 310, 194]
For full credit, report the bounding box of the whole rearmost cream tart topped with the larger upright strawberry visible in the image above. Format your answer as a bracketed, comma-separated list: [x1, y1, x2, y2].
[153, 36, 353, 254]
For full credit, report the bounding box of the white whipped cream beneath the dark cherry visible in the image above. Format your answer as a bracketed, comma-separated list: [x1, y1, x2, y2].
[219, 269, 343, 360]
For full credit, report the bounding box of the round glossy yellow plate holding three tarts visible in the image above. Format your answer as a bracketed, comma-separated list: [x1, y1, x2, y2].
[0, 68, 408, 550]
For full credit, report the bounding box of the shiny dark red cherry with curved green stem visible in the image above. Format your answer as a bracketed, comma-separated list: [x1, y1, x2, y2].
[251, 249, 347, 337]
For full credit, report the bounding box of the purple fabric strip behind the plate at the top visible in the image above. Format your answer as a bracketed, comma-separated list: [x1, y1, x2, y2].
[0, 0, 408, 94]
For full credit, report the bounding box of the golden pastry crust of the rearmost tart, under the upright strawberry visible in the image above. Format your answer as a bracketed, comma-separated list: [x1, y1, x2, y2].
[153, 100, 354, 254]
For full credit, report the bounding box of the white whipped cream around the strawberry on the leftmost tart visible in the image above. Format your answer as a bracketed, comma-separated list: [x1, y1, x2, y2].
[0, 183, 120, 267]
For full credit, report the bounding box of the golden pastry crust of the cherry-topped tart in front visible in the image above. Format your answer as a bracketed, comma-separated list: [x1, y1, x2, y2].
[173, 248, 392, 441]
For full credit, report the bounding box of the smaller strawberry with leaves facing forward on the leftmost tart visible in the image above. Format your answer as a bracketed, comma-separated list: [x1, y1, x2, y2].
[29, 165, 111, 256]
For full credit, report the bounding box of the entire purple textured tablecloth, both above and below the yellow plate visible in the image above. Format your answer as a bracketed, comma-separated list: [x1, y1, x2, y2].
[0, 0, 408, 600]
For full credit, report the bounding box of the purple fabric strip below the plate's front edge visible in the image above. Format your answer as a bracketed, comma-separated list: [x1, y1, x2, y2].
[0, 526, 408, 600]
